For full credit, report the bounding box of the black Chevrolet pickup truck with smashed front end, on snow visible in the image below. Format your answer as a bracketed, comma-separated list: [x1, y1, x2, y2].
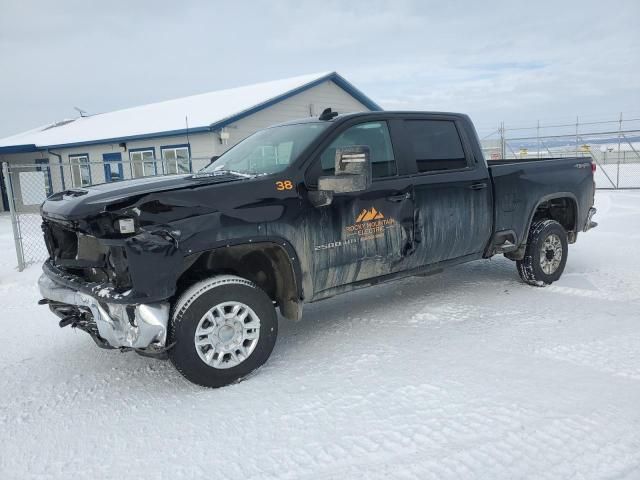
[39, 109, 596, 387]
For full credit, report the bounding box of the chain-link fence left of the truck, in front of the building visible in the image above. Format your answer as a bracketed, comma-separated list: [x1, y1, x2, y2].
[2, 158, 210, 271]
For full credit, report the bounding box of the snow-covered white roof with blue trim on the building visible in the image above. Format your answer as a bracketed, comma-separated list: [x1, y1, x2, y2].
[0, 72, 379, 148]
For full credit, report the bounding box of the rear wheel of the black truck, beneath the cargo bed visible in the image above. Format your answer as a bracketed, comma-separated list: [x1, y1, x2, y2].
[516, 220, 569, 287]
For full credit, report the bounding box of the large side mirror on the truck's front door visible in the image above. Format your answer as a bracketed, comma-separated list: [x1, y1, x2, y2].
[309, 145, 371, 207]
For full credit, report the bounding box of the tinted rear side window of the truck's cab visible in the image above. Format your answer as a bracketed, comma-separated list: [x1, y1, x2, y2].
[404, 120, 468, 173]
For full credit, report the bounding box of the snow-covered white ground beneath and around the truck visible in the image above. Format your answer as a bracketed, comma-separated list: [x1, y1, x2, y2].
[0, 191, 640, 480]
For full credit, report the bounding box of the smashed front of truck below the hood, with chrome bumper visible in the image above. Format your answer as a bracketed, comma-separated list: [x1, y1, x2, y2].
[38, 214, 182, 357]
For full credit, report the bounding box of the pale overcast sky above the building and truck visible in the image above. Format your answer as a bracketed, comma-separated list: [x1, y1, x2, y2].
[0, 0, 640, 137]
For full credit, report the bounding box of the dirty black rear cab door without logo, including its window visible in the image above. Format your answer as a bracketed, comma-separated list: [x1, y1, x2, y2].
[403, 115, 492, 267]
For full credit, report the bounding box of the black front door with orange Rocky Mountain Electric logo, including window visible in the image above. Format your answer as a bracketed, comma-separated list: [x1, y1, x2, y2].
[301, 120, 414, 298]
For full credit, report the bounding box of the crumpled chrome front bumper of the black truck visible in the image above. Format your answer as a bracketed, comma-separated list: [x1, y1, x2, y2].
[38, 273, 169, 350]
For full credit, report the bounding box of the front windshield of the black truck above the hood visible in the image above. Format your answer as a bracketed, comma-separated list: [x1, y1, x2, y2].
[198, 122, 330, 176]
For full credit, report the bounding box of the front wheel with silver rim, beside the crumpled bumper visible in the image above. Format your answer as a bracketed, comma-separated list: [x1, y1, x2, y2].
[168, 275, 278, 388]
